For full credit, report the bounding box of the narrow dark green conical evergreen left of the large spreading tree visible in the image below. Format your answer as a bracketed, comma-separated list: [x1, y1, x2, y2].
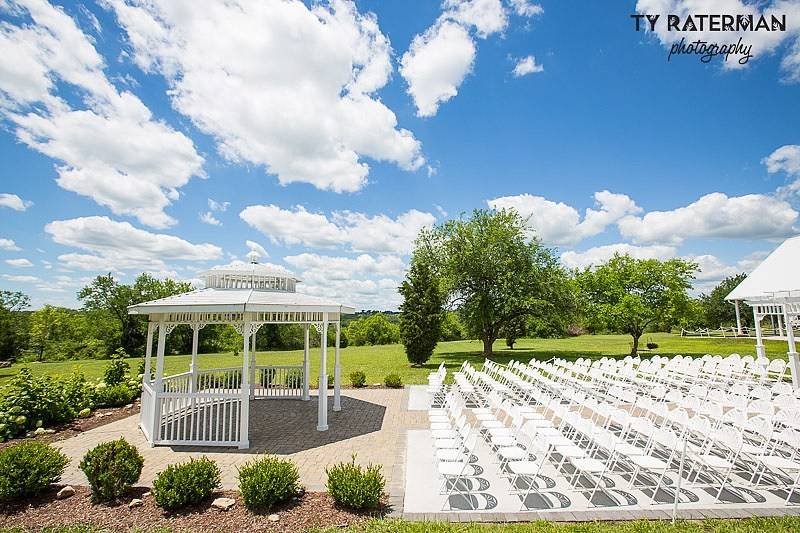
[398, 261, 444, 366]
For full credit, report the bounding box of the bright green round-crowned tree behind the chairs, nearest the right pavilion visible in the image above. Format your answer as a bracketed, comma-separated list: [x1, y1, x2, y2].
[578, 254, 698, 356]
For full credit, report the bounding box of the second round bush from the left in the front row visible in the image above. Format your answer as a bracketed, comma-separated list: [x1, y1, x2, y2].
[80, 438, 144, 502]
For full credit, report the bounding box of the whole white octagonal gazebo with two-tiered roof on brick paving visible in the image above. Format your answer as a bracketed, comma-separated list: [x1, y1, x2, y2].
[128, 255, 355, 448]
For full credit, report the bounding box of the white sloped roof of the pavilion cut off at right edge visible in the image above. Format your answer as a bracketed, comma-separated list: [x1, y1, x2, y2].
[725, 236, 800, 301]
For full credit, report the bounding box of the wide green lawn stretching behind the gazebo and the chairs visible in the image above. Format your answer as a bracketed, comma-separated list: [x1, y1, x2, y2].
[0, 333, 787, 384]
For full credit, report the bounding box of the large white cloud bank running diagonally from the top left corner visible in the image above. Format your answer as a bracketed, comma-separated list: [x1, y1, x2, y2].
[0, 0, 203, 228]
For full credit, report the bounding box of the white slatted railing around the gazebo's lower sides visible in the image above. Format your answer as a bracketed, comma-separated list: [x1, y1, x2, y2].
[140, 365, 304, 446]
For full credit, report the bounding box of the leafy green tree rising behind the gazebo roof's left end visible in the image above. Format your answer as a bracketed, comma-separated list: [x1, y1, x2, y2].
[78, 273, 192, 354]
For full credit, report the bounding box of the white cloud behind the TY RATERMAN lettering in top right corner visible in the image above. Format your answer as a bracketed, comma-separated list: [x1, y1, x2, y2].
[636, 0, 800, 76]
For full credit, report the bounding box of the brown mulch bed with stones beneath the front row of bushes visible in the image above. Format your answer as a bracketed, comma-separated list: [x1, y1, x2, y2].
[0, 487, 378, 533]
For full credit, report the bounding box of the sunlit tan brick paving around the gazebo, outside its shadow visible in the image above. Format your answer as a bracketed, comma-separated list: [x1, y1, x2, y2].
[57, 389, 427, 494]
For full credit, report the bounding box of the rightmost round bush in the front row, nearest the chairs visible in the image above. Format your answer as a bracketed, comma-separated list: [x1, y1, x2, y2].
[325, 455, 386, 509]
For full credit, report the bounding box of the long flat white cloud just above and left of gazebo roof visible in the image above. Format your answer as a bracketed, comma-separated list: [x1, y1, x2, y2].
[44, 216, 222, 271]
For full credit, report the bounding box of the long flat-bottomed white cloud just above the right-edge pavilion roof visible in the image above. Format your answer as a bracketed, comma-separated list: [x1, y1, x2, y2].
[617, 192, 798, 244]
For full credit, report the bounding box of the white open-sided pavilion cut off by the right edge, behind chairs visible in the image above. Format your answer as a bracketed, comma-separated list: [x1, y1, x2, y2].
[725, 237, 800, 388]
